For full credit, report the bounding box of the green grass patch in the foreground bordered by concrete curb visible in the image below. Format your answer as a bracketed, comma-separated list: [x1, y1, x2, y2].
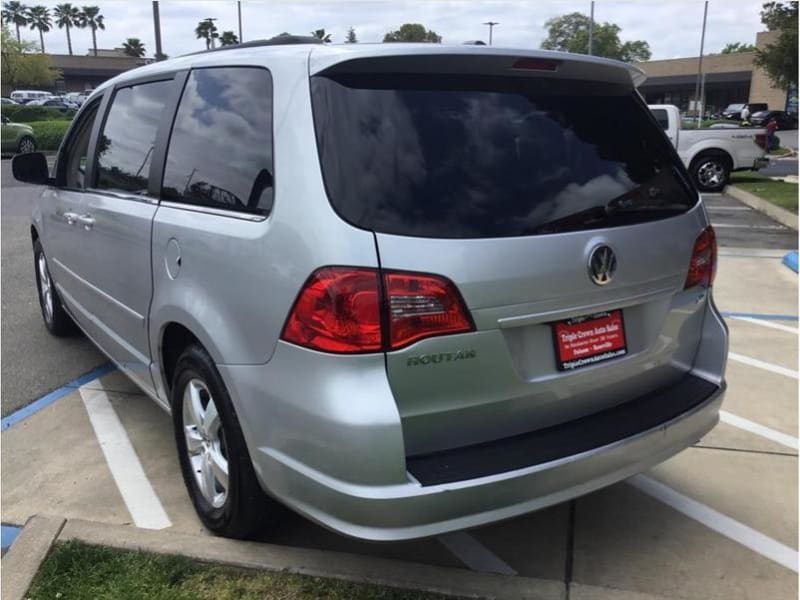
[26, 541, 456, 600]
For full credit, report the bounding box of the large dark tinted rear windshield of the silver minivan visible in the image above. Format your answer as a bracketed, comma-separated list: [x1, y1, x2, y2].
[311, 73, 697, 238]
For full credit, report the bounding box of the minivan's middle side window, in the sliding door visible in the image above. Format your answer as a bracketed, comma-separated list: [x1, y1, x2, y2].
[97, 80, 172, 194]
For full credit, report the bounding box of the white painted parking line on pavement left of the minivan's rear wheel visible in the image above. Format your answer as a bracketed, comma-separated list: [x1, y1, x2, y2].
[79, 381, 172, 529]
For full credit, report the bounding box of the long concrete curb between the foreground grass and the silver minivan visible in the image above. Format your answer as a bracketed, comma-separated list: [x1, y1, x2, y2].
[57, 519, 567, 600]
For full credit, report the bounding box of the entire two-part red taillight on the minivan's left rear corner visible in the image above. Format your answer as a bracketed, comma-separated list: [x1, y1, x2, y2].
[281, 267, 475, 354]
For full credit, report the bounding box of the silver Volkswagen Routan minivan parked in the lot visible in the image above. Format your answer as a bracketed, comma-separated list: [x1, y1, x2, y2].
[13, 37, 727, 540]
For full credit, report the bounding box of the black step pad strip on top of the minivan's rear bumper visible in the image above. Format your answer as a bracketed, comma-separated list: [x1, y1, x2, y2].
[406, 374, 719, 486]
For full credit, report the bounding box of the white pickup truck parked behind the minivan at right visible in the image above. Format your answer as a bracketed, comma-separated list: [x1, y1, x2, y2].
[649, 104, 769, 192]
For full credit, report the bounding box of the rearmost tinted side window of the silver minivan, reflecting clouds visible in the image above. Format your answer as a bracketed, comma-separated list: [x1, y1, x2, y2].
[161, 67, 273, 215]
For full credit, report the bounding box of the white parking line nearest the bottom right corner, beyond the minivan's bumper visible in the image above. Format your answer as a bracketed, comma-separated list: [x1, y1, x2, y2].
[628, 475, 798, 573]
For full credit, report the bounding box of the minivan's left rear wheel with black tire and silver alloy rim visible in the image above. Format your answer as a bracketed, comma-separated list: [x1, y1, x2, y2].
[171, 345, 280, 539]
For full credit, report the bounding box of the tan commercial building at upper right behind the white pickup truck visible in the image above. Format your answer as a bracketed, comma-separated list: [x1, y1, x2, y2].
[637, 31, 797, 113]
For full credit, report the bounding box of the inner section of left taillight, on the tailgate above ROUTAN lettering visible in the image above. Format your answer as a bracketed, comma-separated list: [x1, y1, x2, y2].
[384, 272, 473, 350]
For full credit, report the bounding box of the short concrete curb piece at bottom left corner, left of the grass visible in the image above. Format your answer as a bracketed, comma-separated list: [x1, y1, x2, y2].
[0, 515, 65, 600]
